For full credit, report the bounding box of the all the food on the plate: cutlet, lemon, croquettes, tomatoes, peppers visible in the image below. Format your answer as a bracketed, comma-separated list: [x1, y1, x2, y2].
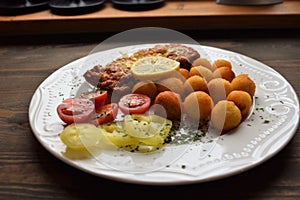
[57, 44, 256, 152]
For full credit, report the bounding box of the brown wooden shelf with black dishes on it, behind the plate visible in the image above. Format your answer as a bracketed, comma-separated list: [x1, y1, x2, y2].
[0, 0, 300, 35]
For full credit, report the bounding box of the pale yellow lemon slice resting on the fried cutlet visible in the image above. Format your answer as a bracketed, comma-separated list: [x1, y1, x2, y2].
[131, 56, 180, 80]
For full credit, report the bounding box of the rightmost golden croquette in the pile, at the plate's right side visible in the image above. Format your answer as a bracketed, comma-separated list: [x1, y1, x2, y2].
[231, 74, 256, 98]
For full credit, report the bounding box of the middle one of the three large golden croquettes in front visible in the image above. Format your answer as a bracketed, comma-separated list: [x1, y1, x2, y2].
[183, 91, 214, 121]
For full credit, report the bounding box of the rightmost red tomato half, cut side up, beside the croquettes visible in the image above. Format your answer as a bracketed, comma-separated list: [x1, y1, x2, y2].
[119, 94, 151, 114]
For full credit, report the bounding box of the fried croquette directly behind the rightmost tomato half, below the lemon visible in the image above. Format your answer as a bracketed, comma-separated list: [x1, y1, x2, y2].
[132, 81, 157, 100]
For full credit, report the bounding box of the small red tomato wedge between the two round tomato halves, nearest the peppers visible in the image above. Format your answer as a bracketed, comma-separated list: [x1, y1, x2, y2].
[91, 103, 118, 125]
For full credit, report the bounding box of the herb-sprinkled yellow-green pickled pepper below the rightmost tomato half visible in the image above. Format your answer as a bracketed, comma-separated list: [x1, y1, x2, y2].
[100, 114, 172, 152]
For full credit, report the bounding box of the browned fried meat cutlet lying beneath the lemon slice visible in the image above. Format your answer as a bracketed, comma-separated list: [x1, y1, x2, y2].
[84, 44, 200, 91]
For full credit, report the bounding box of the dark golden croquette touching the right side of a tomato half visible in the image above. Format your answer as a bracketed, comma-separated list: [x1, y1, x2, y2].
[154, 91, 181, 120]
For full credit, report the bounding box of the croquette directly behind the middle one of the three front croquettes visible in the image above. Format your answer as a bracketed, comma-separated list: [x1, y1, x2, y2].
[183, 75, 208, 94]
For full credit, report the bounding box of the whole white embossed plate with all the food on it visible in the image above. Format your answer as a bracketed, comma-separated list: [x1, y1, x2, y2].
[29, 44, 299, 184]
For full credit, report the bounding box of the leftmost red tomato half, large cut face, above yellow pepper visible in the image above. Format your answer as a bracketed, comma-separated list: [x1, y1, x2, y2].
[56, 97, 95, 124]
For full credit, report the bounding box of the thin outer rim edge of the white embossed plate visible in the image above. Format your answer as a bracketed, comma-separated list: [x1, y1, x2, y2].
[28, 44, 299, 185]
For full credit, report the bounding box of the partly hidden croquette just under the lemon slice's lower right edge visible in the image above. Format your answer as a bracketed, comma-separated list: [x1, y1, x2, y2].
[156, 77, 183, 94]
